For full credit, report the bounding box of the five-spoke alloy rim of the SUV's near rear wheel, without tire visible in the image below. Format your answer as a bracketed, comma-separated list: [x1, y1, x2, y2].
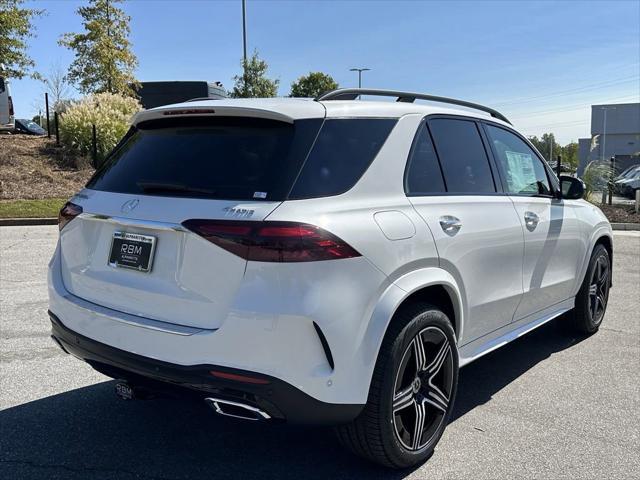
[392, 327, 454, 451]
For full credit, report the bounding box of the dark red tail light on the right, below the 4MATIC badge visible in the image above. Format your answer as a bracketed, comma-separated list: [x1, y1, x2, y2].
[182, 220, 360, 262]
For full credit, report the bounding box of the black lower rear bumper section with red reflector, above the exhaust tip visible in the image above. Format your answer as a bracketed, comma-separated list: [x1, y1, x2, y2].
[49, 312, 364, 425]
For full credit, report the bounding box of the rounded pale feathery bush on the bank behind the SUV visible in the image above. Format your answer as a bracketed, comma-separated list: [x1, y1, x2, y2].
[60, 93, 142, 166]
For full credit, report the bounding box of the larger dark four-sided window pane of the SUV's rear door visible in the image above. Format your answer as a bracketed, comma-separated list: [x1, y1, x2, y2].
[429, 118, 496, 193]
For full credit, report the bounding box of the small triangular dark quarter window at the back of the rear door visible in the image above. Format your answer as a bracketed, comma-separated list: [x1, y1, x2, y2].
[404, 123, 446, 195]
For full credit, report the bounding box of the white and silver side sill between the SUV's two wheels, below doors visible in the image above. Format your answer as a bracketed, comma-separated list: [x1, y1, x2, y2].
[460, 298, 574, 367]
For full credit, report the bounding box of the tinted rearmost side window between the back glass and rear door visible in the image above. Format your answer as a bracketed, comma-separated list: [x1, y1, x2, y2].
[289, 118, 396, 199]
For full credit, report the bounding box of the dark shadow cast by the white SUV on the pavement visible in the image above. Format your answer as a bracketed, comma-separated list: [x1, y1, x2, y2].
[0, 316, 579, 479]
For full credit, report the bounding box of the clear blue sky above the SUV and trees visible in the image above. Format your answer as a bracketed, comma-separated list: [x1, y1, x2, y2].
[12, 0, 640, 143]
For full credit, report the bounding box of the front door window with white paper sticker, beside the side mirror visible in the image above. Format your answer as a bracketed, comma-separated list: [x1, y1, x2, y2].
[487, 125, 552, 195]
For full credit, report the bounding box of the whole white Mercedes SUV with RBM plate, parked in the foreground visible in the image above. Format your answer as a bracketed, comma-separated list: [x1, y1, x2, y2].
[49, 89, 612, 467]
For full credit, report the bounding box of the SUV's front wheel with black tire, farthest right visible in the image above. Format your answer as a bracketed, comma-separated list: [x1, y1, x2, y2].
[573, 244, 611, 335]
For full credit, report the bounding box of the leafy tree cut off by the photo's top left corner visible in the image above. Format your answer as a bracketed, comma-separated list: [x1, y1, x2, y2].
[0, 0, 44, 78]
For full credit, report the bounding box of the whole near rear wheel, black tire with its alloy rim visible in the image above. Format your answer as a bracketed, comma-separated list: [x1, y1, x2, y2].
[336, 303, 458, 468]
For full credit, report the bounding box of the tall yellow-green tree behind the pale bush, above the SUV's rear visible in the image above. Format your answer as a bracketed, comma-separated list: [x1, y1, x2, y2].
[58, 0, 138, 95]
